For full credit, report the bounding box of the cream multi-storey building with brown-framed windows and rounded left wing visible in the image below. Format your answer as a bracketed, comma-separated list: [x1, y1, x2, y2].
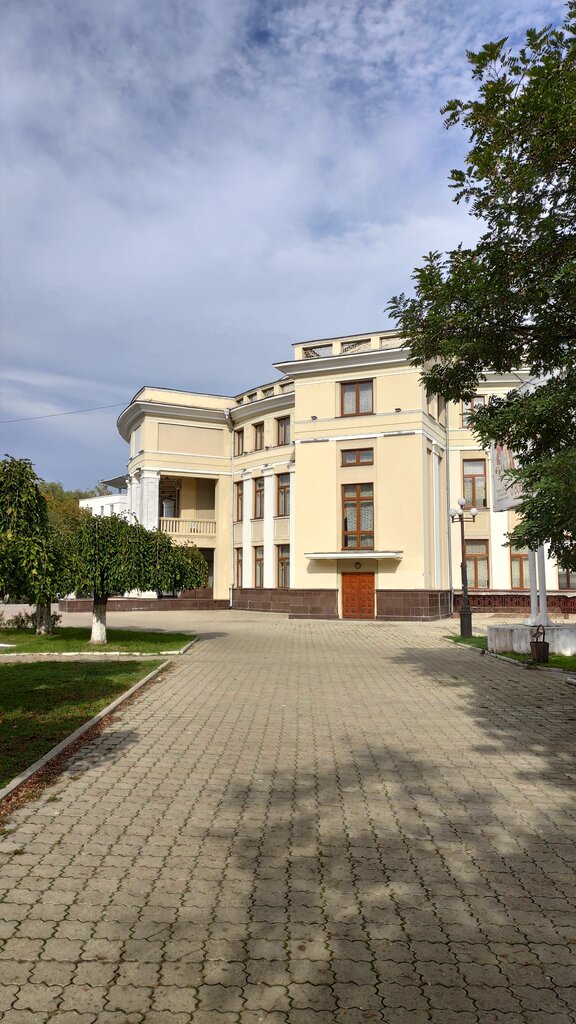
[118, 332, 574, 620]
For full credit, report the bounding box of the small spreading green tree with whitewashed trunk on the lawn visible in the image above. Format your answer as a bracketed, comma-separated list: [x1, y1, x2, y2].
[74, 515, 207, 644]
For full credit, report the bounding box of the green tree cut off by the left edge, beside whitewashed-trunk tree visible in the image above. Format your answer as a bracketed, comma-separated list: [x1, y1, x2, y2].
[0, 456, 68, 633]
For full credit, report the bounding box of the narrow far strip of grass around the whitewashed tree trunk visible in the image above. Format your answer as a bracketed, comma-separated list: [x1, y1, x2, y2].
[0, 626, 194, 654]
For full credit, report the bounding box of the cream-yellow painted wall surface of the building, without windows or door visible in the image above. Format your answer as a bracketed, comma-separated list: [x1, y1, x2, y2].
[121, 332, 532, 598]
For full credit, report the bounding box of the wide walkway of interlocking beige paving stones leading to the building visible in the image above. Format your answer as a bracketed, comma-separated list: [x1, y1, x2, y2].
[0, 612, 576, 1024]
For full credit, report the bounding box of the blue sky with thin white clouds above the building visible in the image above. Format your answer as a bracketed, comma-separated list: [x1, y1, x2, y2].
[0, 0, 564, 487]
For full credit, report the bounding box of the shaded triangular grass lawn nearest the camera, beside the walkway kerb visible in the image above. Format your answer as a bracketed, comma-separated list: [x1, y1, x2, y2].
[0, 662, 161, 788]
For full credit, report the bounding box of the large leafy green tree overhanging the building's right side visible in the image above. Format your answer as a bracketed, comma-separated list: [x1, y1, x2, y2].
[387, 6, 576, 569]
